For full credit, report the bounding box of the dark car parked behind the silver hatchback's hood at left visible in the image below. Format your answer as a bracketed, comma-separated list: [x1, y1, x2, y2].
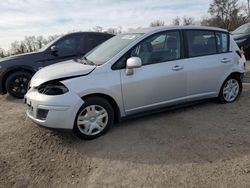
[0, 32, 114, 98]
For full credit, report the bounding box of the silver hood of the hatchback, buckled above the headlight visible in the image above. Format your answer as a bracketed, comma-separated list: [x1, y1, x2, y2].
[30, 60, 96, 87]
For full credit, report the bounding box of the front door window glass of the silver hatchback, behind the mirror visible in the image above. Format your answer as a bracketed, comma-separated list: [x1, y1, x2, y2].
[130, 31, 181, 65]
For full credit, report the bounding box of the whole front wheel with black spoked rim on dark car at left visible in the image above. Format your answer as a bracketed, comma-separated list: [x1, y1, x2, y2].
[5, 71, 32, 99]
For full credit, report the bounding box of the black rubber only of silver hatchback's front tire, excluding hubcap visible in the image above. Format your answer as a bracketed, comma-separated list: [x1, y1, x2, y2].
[73, 97, 114, 140]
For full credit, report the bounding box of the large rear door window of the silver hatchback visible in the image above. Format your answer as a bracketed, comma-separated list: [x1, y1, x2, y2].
[186, 30, 216, 57]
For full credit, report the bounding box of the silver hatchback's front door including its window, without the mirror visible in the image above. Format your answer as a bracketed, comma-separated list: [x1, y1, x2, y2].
[121, 31, 187, 115]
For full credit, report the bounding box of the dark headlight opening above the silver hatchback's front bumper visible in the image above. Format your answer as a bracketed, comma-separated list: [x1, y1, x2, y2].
[37, 81, 69, 95]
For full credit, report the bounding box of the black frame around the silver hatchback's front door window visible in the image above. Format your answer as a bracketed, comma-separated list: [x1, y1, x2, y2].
[111, 29, 185, 70]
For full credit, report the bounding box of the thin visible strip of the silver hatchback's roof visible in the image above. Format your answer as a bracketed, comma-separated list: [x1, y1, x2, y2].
[128, 25, 228, 34]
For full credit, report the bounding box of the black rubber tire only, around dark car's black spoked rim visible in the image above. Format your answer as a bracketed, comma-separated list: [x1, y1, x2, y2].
[5, 71, 32, 99]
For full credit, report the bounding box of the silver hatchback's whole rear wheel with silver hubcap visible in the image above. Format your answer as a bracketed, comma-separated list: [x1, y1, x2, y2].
[218, 75, 242, 104]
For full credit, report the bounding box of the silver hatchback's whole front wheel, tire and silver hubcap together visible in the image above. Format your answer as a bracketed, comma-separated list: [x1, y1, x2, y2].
[73, 97, 114, 140]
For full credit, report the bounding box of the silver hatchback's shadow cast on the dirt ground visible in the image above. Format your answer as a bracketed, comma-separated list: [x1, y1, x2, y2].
[50, 90, 250, 164]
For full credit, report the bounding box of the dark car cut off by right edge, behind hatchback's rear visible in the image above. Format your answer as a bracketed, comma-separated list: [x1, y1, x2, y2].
[232, 23, 250, 59]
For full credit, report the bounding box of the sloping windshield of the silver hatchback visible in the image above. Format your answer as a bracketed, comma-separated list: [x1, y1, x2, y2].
[86, 34, 142, 65]
